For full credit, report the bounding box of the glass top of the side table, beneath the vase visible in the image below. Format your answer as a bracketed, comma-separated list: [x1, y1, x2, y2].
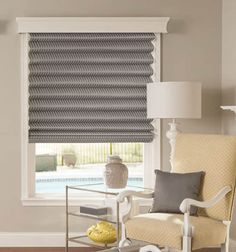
[67, 183, 153, 195]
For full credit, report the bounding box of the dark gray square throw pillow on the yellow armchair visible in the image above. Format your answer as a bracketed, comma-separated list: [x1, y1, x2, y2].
[151, 170, 204, 215]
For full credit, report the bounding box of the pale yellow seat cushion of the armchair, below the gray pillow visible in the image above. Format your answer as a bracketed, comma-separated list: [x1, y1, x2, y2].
[125, 213, 226, 250]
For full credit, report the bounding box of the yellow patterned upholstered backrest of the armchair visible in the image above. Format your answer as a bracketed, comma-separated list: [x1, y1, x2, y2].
[172, 134, 236, 220]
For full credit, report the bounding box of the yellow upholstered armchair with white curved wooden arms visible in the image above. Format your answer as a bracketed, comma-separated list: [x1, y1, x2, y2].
[117, 134, 236, 252]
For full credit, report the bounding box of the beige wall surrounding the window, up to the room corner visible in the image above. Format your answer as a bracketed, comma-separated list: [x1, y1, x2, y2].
[0, 0, 221, 232]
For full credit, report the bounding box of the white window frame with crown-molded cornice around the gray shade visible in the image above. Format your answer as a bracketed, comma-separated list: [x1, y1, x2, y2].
[16, 17, 169, 206]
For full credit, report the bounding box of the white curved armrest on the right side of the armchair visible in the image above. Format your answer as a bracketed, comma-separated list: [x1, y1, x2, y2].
[179, 186, 232, 213]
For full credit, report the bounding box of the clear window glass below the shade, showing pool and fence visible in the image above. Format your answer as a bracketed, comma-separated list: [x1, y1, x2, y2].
[35, 143, 143, 193]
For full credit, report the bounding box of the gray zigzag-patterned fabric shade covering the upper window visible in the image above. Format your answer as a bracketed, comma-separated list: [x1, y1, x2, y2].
[29, 33, 155, 143]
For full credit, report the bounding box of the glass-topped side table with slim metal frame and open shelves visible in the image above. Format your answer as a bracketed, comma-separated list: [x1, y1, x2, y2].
[65, 183, 150, 252]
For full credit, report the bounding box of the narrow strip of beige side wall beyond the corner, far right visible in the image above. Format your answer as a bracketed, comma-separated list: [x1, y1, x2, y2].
[222, 0, 236, 240]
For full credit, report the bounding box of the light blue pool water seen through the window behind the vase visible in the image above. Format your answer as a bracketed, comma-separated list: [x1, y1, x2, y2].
[35, 178, 143, 193]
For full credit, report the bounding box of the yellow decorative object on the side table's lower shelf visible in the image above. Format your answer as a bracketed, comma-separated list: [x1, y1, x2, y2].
[87, 221, 116, 244]
